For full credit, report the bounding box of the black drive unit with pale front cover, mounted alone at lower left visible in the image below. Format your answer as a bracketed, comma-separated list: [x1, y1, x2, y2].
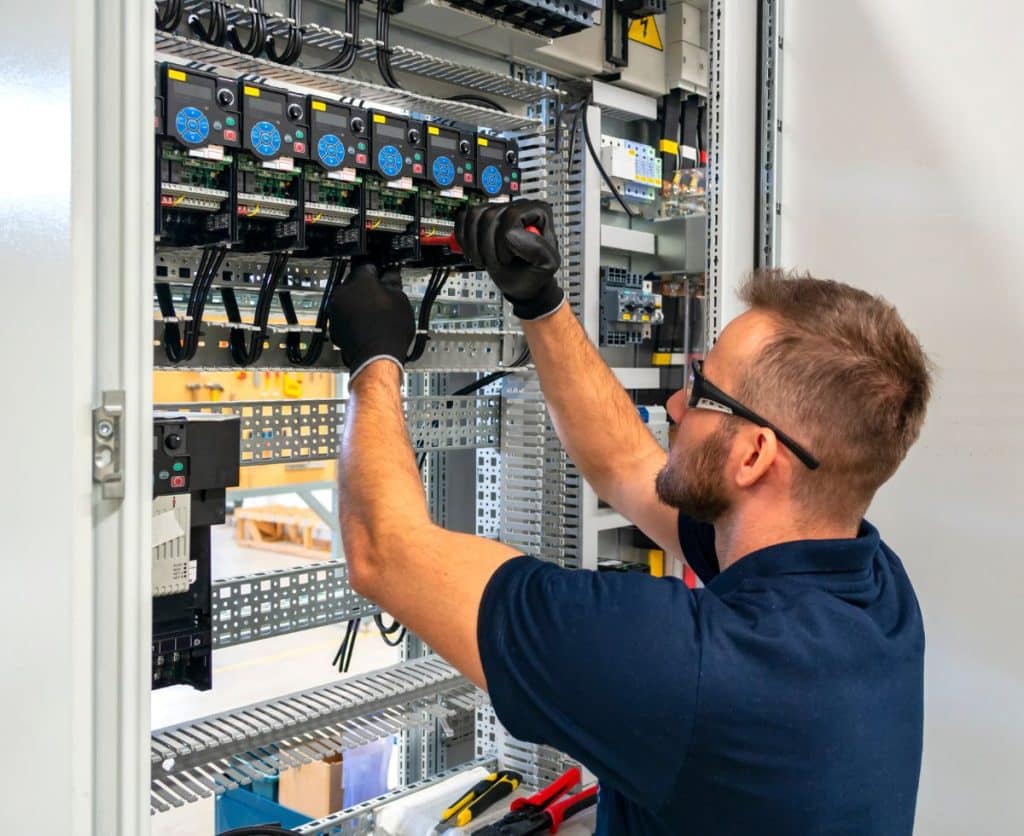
[152, 412, 241, 691]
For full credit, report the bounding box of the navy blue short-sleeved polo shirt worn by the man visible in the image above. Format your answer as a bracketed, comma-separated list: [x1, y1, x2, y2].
[478, 517, 925, 836]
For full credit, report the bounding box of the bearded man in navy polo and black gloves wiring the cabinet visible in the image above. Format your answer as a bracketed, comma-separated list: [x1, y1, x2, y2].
[332, 201, 931, 836]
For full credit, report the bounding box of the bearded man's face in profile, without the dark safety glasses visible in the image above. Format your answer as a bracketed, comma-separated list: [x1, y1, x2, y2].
[655, 312, 773, 523]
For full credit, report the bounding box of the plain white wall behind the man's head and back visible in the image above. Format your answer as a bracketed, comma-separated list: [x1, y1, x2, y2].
[779, 0, 1024, 836]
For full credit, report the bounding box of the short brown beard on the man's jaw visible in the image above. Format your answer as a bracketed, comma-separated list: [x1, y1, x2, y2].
[654, 426, 735, 523]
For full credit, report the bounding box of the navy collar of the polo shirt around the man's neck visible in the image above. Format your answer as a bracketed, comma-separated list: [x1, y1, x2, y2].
[708, 519, 881, 595]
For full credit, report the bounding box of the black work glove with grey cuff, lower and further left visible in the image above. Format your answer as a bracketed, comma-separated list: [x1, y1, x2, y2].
[328, 263, 416, 379]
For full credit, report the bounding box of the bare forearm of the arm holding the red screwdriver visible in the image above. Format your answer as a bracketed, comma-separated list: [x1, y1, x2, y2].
[522, 304, 664, 501]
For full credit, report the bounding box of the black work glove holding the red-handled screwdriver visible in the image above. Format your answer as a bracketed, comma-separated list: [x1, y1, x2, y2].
[455, 200, 565, 320]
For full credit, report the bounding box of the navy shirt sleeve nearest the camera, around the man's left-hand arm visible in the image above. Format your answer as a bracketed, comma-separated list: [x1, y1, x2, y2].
[477, 557, 702, 808]
